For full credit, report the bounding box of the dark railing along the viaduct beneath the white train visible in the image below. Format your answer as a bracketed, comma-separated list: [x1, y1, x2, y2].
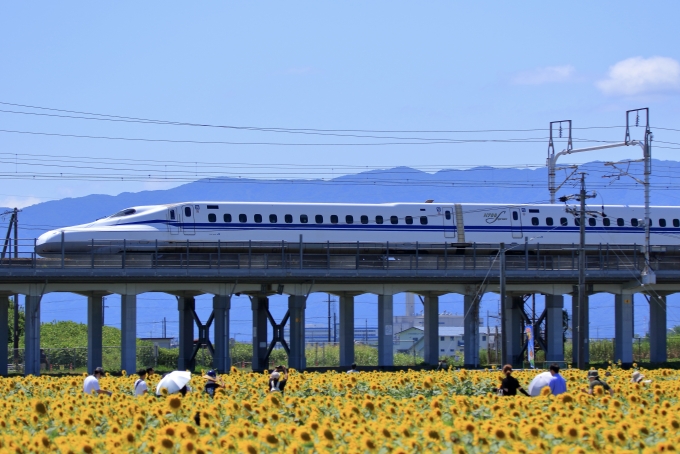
[0, 240, 680, 272]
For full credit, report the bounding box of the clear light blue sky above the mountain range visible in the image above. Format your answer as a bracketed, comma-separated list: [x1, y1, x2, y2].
[0, 1, 680, 206]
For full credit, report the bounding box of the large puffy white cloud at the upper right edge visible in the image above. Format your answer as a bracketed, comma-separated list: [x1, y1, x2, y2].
[596, 57, 680, 95]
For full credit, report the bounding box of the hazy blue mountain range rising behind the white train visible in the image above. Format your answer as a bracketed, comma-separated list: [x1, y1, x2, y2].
[19, 161, 680, 238]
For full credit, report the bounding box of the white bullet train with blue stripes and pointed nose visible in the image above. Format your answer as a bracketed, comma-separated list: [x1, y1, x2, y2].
[36, 201, 680, 256]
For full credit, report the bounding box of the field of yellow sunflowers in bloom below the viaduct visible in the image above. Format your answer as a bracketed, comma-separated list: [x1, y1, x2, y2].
[0, 367, 680, 454]
